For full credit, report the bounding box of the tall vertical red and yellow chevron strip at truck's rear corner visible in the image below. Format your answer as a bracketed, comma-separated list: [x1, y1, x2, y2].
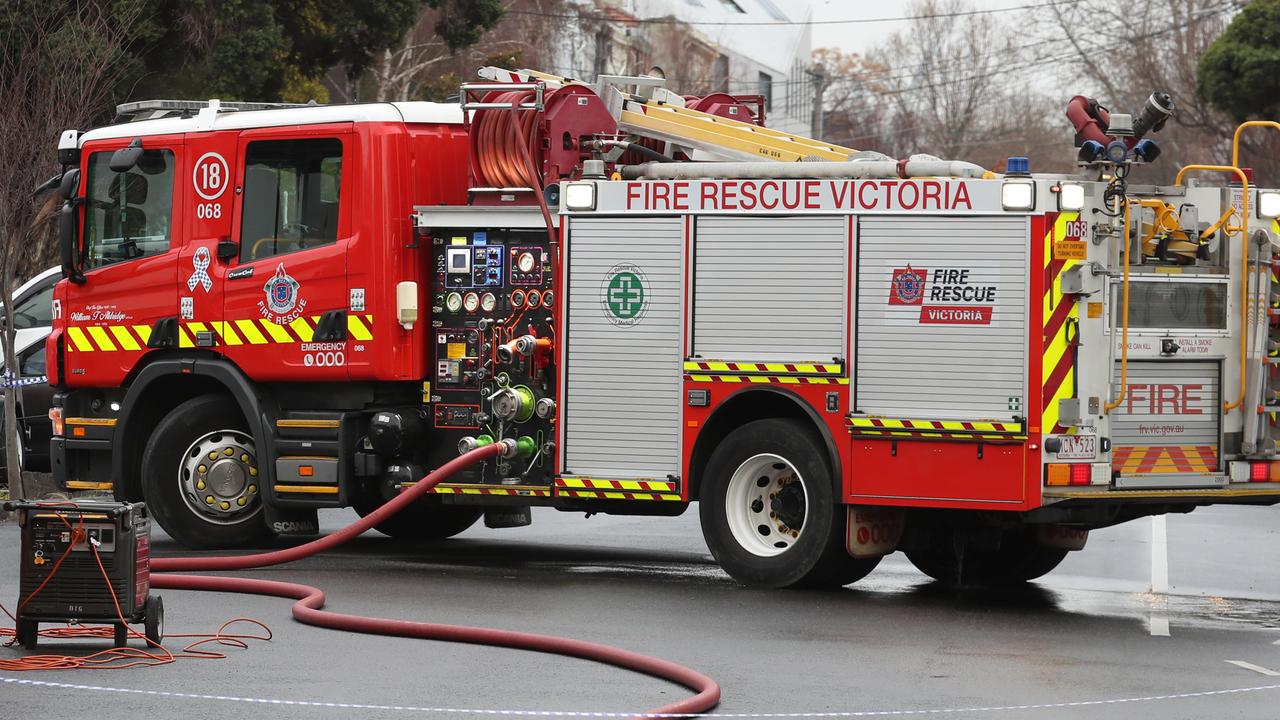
[1041, 207, 1080, 433]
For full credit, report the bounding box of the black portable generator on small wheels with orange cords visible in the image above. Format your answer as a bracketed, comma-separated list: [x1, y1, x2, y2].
[4, 501, 164, 650]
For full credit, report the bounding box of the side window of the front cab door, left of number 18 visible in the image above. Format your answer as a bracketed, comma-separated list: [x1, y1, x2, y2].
[84, 150, 174, 268]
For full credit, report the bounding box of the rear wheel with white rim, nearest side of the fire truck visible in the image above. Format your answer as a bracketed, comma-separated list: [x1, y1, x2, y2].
[699, 419, 881, 588]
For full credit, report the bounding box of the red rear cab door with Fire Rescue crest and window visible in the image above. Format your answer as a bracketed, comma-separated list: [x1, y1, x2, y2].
[223, 123, 356, 380]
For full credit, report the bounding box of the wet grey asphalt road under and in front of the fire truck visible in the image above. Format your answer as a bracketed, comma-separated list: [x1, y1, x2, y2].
[0, 507, 1280, 720]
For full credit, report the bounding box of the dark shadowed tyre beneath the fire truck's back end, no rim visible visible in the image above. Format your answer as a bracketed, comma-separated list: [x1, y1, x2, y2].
[906, 528, 1068, 587]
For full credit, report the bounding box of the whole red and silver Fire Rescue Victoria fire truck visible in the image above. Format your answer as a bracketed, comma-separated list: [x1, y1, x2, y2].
[47, 68, 1280, 587]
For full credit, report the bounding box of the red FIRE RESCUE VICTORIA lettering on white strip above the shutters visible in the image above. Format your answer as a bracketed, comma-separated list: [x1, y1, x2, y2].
[626, 179, 973, 213]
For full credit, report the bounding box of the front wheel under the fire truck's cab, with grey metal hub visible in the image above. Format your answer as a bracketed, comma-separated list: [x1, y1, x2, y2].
[142, 395, 271, 548]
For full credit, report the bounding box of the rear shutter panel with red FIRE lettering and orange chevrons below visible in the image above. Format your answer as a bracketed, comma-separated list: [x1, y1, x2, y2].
[1111, 360, 1226, 488]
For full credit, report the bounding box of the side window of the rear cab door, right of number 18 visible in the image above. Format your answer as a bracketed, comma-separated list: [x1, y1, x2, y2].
[241, 138, 342, 263]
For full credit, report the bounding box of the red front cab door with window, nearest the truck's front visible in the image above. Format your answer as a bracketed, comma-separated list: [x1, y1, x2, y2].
[58, 136, 187, 387]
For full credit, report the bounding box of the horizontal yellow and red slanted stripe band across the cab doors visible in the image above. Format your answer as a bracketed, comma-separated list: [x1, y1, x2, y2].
[67, 315, 374, 352]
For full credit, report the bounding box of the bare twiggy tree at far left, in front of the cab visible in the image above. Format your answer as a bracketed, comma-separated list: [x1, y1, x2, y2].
[0, 0, 140, 496]
